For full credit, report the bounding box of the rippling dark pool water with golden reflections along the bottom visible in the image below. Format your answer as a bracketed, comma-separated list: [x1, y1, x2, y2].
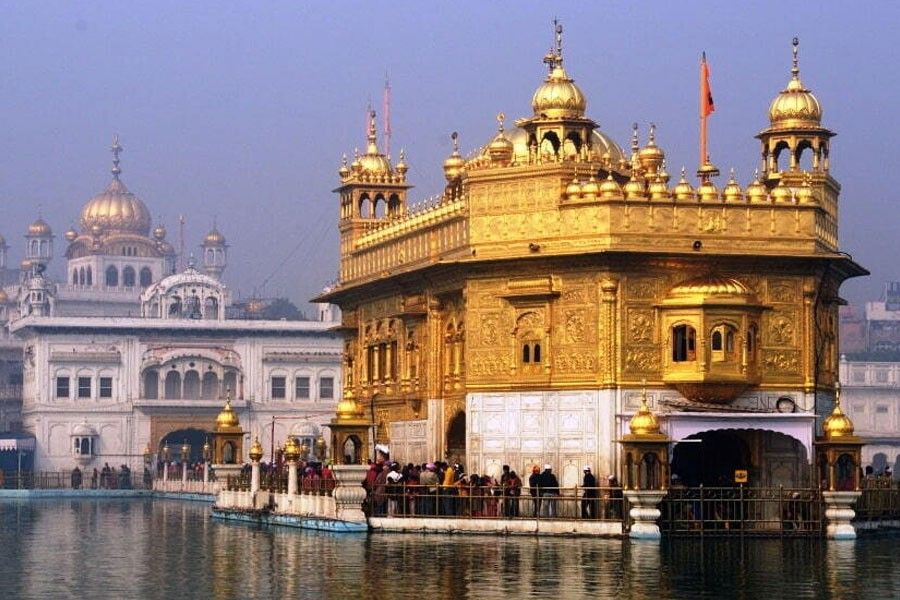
[0, 500, 900, 600]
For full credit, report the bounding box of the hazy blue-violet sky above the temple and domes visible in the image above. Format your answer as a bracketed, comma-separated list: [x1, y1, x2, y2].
[0, 0, 900, 303]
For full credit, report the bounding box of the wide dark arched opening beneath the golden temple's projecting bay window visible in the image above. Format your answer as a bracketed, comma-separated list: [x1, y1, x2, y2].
[671, 429, 812, 488]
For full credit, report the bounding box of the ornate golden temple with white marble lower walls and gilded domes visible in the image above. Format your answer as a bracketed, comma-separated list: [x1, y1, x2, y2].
[319, 27, 866, 484]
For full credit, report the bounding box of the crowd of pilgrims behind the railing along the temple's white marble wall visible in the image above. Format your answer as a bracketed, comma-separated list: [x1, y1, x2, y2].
[363, 460, 622, 519]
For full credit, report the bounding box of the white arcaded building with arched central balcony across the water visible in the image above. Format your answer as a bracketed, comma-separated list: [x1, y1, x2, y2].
[10, 268, 342, 470]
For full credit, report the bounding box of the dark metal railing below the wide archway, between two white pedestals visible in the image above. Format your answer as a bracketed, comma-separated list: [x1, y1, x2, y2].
[659, 486, 825, 536]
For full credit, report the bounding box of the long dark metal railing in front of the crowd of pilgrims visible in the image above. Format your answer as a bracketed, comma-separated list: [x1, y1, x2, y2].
[366, 484, 627, 521]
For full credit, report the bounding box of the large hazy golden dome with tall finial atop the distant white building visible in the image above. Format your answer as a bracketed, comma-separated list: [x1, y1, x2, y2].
[81, 136, 150, 236]
